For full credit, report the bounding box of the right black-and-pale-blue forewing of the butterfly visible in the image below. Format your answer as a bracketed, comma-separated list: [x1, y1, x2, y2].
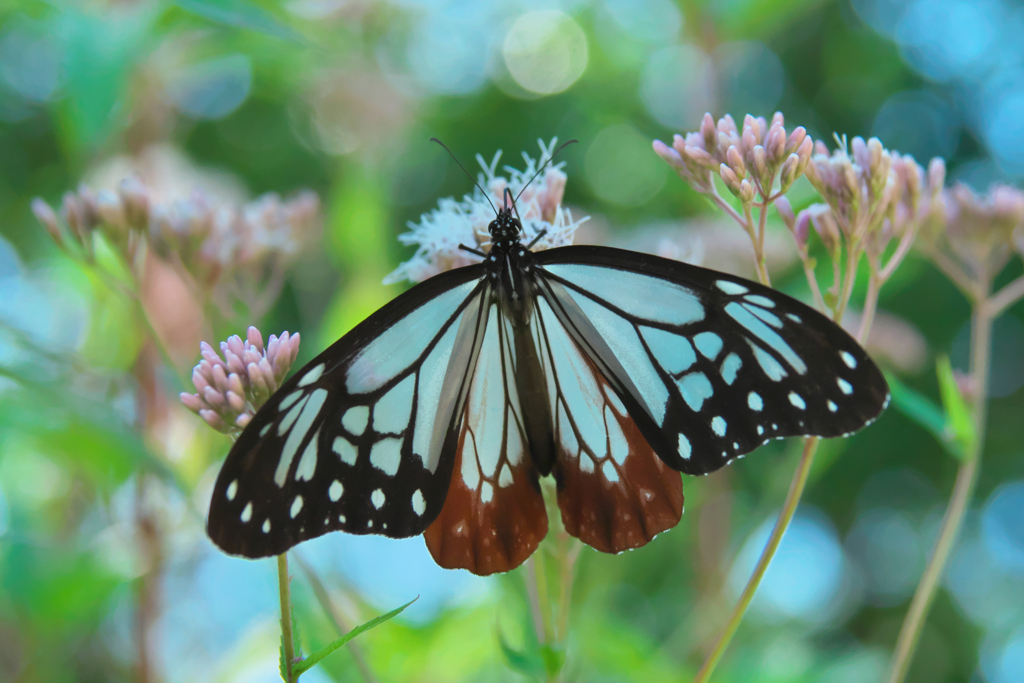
[536, 246, 889, 474]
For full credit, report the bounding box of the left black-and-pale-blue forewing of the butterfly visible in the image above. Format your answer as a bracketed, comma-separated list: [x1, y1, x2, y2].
[207, 266, 487, 557]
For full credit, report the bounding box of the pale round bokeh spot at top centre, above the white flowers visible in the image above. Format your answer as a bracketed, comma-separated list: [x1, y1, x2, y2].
[502, 9, 588, 95]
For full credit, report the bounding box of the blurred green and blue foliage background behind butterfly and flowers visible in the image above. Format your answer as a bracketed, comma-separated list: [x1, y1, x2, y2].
[0, 0, 1024, 683]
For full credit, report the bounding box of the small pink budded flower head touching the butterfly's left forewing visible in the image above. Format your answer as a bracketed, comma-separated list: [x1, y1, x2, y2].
[180, 327, 299, 434]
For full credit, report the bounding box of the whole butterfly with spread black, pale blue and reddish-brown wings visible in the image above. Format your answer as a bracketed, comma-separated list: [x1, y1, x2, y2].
[207, 152, 889, 574]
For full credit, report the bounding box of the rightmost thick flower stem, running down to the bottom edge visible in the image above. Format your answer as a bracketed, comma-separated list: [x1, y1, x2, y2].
[889, 300, 993, 683]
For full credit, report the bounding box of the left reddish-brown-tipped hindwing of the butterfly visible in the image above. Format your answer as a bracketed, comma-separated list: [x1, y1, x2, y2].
[424, 302, 548, 575]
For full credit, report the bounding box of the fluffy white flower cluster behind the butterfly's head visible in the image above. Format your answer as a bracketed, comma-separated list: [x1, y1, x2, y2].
[384, 138, 588, 285]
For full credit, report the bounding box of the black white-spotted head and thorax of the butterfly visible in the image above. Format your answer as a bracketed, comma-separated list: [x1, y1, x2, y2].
[484, 209, 532, 325]
